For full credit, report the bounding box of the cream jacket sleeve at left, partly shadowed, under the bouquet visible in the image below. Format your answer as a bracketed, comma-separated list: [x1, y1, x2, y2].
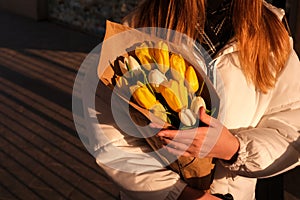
[93, 83, 186, 200]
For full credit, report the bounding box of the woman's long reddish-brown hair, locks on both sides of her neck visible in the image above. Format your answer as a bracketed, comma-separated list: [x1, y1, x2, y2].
[125, 0, 290, 93]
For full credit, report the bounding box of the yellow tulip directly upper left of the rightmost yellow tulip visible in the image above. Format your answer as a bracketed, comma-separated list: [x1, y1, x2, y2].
[170, 54, 186, 81]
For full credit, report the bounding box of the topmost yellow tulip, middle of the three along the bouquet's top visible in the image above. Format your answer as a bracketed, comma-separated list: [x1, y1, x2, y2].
[152, 41, 170, 74]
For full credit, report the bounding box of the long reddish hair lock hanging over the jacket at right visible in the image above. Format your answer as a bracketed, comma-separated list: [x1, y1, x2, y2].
[233, 0, 290, 93]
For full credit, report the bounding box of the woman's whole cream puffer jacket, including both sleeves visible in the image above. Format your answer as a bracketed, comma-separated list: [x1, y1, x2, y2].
[94, 3, 300, 200]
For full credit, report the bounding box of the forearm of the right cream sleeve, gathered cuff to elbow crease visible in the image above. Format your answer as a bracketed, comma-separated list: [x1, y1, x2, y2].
[224, 109, 300, 177]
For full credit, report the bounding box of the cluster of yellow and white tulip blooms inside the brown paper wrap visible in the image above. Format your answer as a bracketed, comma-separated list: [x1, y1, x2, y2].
[112, 41, 211, 128]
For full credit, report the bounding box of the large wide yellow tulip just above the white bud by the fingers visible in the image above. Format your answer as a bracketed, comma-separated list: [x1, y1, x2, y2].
[160, 79, 188, 112]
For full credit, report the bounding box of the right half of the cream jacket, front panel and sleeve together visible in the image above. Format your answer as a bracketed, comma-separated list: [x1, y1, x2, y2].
[211, 38, 300, 200]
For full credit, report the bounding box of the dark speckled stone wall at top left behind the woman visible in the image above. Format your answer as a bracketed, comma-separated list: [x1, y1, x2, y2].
[48, 0, 139, 34]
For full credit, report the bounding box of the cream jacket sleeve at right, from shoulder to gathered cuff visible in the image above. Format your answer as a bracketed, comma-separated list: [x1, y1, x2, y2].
[223, 48, 300, 178]
